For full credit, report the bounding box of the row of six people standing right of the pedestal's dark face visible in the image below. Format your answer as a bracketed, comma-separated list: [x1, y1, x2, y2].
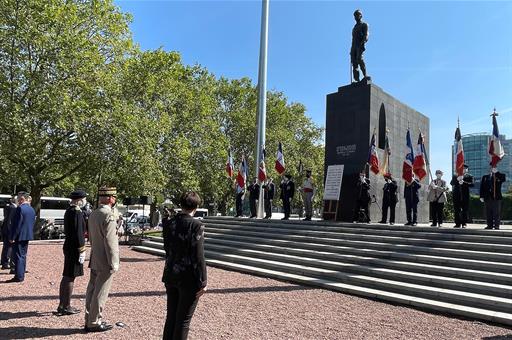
[353, 164, 506, 229]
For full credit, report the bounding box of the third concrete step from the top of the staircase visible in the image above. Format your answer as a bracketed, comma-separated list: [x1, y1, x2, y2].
[206, 227, 512, 263]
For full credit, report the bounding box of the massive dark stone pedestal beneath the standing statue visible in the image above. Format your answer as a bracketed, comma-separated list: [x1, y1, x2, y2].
[325, 80, 430, 223]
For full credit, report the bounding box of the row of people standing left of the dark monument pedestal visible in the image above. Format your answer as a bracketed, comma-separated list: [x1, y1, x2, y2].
[235, 170, 316, 221]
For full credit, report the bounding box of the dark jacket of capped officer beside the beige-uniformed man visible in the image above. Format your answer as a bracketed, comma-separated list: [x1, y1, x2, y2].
[63, 205, 85, 257]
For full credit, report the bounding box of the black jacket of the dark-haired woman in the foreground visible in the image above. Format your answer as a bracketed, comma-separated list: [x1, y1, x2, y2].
[162, 213, 207, 290]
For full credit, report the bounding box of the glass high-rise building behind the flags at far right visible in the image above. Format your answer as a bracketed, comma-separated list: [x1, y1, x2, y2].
[452, 132, 512, 194]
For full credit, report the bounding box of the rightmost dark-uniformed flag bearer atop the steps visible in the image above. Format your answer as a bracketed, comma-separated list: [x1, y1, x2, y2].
[480, 164, 506, 229]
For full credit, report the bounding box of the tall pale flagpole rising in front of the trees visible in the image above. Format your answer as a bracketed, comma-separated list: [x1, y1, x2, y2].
[255, 0, 269, 218]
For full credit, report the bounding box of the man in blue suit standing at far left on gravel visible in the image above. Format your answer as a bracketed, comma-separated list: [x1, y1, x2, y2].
[8, 192, 36, 282]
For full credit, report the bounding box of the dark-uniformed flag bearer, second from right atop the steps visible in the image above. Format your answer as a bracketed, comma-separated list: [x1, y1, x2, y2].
[450, 164, 474, 228]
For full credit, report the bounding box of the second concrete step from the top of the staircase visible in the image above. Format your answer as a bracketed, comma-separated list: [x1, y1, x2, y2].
[206, 224, 512, 254]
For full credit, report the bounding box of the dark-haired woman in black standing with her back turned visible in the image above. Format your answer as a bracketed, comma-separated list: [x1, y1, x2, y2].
[162, 191, 207, 340]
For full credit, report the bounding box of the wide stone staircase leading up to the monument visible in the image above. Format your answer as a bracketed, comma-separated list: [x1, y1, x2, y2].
[133, 217, 512, 325]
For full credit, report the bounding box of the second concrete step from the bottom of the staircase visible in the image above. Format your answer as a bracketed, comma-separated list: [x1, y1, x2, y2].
[205, 251, 512, 313]
